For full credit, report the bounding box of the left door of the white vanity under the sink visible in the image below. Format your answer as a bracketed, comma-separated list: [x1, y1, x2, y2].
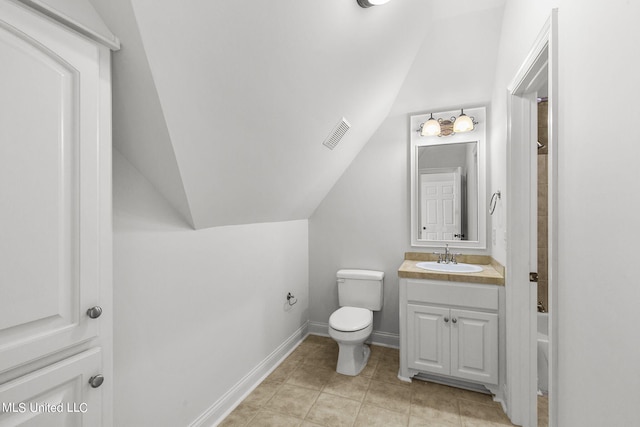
[407, 304, 450, 375]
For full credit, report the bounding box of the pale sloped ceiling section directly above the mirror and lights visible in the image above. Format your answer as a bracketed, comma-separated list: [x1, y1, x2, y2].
[389, 0, 505, 115]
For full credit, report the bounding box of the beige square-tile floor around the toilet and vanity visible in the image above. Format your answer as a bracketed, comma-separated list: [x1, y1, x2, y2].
[220, 335, 528, 427]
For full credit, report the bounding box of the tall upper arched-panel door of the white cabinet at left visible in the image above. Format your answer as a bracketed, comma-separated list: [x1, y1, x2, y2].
[0, 0, 100, 372]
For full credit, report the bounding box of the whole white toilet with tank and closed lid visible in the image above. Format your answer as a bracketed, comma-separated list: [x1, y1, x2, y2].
[329, 270, 384, 376]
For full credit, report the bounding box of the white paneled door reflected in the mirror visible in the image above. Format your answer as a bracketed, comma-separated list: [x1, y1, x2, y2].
[420, 172, 462, 240]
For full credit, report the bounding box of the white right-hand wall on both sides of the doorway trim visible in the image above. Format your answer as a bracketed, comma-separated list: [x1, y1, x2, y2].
[491, 0, 640, 427]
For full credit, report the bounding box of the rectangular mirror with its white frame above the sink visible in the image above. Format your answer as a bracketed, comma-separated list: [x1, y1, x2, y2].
[410, 108, 487, 249]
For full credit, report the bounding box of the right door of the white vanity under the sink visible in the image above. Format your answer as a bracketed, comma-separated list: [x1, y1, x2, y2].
[451, 309, 498, 384]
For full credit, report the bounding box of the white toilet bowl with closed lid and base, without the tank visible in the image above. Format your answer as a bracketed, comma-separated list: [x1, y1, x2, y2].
[329, 307, 373, 376]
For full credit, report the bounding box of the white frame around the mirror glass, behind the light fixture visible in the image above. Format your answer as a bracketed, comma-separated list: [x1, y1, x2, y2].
[409, 107, 487, 249]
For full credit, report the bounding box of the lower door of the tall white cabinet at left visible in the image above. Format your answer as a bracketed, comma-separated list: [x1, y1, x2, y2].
[0, 348, 102, 427]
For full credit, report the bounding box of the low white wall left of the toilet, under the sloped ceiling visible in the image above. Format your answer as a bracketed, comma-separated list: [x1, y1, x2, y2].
[113, 151, 309, 426]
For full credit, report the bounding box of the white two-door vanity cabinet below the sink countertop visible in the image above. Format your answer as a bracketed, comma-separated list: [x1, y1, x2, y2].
[399, 278, 499, 385]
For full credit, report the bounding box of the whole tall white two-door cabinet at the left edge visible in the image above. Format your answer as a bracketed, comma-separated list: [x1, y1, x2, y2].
[0, 0, 113, 427]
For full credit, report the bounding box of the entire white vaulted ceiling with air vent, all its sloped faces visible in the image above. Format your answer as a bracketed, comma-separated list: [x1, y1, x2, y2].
[91, 0, 504, 228]
